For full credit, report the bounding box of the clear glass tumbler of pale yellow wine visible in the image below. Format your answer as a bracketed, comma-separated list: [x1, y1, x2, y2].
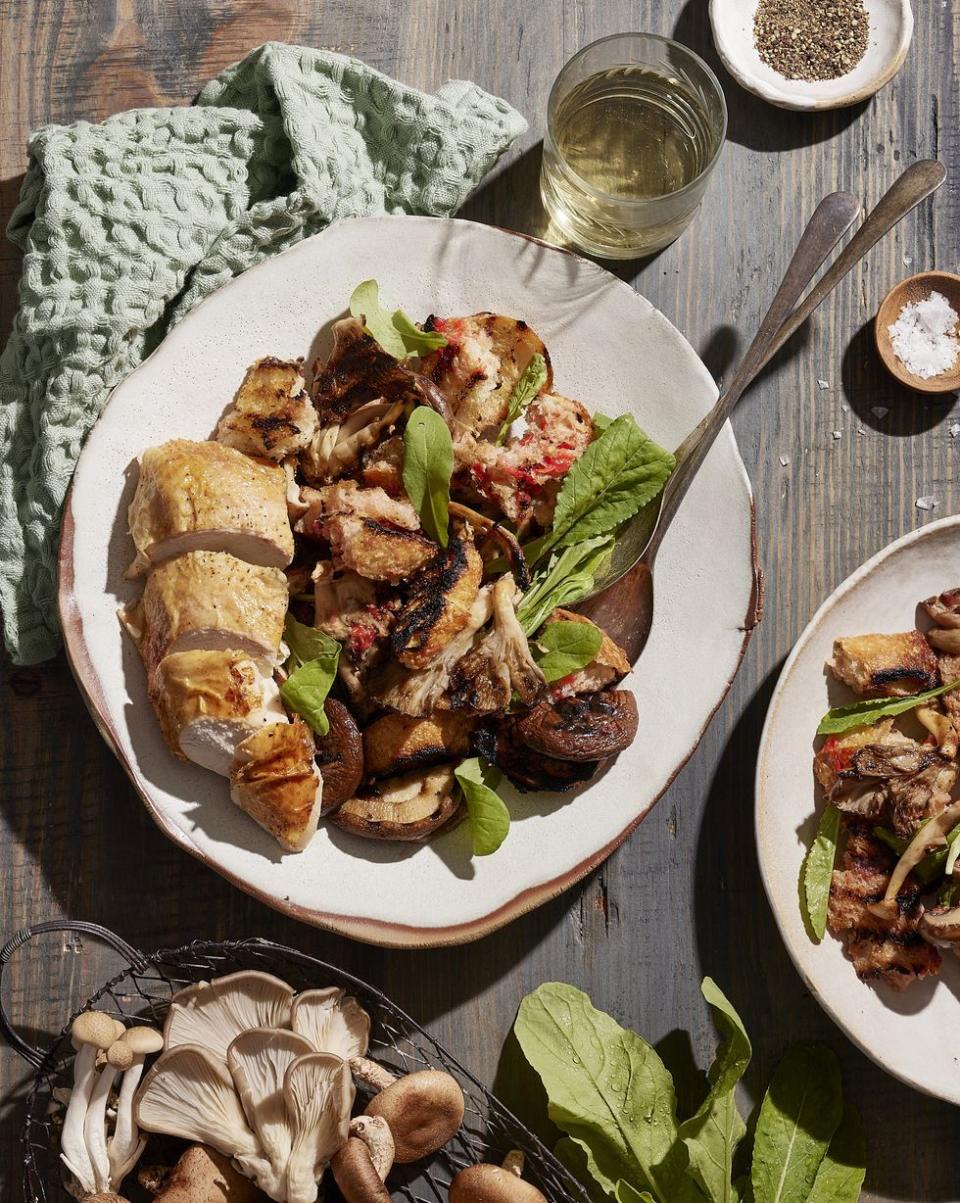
[540, 34, 727, 259]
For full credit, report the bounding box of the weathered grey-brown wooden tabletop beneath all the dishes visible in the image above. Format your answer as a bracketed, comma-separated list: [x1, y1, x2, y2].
[0, 0, 960, 1201]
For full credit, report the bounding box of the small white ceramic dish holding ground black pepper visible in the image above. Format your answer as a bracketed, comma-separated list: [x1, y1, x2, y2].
[710, 0, 913, 112]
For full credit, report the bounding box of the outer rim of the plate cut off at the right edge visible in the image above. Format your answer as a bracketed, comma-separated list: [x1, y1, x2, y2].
[753, 514, 960, 1104]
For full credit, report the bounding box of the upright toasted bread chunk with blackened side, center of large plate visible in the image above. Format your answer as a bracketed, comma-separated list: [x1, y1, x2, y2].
[390, 533, 484, 669]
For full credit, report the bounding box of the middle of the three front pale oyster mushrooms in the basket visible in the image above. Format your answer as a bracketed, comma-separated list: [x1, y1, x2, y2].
[226, 1027, 314, 1186]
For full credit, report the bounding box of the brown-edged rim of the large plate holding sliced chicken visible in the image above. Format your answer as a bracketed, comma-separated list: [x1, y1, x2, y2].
[57, 214, 764, 949]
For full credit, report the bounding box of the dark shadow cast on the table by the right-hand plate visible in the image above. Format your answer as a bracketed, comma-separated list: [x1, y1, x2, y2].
[694, 665, 960, 1203]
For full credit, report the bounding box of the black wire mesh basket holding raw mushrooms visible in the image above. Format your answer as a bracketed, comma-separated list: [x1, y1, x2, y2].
[0, 920, 589, 1203]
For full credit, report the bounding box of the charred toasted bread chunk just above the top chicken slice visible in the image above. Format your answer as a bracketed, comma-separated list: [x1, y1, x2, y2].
[217, 356, 316, 462]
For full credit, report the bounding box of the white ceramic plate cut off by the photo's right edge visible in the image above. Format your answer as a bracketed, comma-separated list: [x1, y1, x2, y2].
[757, 516, 960, 1103]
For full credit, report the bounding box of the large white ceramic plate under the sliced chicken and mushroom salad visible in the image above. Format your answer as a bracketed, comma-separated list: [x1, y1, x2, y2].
[60, 218, 755, 946]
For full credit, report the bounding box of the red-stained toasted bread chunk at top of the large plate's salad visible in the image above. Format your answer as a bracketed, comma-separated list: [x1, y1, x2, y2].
[421, 313, 552, 443]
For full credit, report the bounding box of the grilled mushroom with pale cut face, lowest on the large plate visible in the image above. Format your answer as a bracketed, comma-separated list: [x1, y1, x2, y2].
[331, 765, 460, 840]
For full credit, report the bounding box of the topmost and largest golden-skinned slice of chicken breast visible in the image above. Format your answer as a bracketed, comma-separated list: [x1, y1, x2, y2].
[128, 439, 294, 576]
